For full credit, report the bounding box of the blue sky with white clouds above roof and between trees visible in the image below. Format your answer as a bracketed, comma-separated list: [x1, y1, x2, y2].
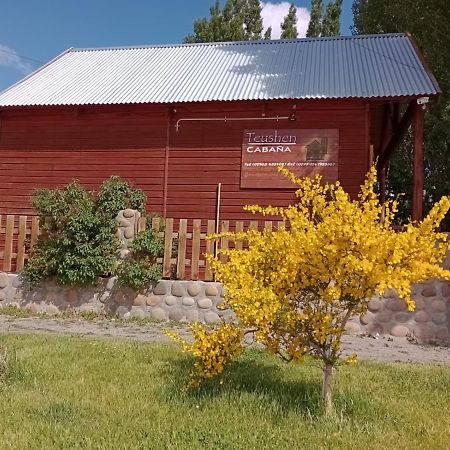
[0, 0, 352, 91]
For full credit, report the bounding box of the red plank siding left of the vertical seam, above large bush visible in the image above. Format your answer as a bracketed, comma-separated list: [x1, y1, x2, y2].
[0, 103, 166, 214]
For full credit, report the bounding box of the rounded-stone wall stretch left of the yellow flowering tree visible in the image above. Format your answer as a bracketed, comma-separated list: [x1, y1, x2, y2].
[0, 273, 232, 323]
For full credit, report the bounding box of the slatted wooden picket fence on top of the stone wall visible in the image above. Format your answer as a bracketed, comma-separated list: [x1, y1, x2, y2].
[0, 215, 284, 281]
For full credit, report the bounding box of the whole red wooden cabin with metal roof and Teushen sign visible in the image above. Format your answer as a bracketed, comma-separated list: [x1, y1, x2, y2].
[0, 34, 440, 220]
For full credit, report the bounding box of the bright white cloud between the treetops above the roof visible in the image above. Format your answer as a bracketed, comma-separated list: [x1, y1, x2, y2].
[261, 2, 310, 39]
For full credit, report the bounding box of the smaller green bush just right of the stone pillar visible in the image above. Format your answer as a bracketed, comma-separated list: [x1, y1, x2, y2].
[116, 228, 164, 291]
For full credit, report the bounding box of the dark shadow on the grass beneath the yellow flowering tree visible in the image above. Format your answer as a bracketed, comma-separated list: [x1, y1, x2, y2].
[161, 349, 385, 421]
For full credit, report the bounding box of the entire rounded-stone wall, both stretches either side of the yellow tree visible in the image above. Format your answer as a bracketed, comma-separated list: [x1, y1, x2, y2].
[0, 273, 450, 344]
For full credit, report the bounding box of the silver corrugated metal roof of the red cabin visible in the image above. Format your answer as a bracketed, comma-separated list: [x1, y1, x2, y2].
[0, 34, 439, 106]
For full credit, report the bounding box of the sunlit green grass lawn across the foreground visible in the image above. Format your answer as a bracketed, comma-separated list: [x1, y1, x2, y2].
[0, 334, 450, 450]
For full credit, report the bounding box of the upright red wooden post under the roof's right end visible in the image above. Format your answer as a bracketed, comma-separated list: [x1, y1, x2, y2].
[412, 104, 426, 220]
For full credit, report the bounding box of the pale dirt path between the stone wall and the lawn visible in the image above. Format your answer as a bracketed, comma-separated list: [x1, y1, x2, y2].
[0, 315, 450, 364]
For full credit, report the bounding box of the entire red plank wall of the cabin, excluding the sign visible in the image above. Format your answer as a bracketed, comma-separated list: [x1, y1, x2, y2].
[0, 100, 370, 219]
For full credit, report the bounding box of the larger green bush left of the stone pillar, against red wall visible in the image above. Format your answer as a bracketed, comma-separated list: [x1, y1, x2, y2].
[23, 177, 145, 285]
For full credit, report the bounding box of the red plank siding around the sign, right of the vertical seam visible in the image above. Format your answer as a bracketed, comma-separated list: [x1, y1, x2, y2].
[167, 101, 368, 220]
